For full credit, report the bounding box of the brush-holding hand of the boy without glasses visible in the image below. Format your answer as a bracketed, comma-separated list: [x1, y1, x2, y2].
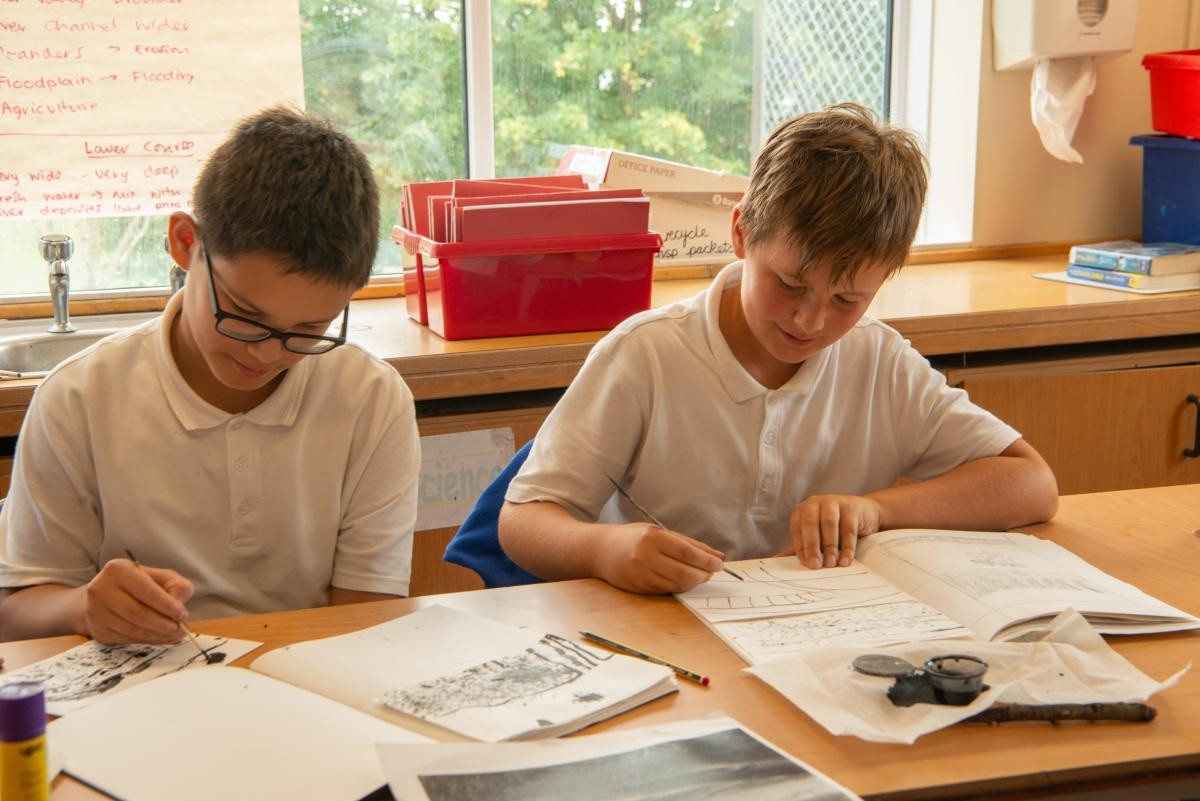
[595, 523, 725, 592]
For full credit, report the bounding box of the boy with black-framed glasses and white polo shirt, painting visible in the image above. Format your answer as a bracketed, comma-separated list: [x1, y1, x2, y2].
[0, 108, 420, 643]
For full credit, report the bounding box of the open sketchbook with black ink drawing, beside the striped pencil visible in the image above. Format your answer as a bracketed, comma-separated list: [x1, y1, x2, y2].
[251, 606, 678, 742]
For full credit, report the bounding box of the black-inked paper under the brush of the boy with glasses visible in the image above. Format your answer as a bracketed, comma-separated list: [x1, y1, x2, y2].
[0, 634, 262, 715]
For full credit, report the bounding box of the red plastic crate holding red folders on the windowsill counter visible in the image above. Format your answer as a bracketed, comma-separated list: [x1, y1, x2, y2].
[391, 225, 662, 339]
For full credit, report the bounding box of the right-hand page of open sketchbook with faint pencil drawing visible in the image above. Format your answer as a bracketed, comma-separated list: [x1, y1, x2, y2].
[858, 529, 1200, 639]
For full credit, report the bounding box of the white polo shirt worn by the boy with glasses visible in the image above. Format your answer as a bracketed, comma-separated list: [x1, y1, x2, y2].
[0, 295, 420, 619]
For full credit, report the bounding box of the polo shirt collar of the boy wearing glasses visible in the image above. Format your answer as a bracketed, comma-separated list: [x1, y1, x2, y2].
[155, 291, 313, 430]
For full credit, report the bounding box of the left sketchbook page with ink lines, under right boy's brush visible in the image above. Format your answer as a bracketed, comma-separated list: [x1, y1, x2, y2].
[677, 556, 973, 664]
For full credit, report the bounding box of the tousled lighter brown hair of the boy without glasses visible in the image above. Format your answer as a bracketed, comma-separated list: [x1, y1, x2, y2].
[738, 103, 928, 281]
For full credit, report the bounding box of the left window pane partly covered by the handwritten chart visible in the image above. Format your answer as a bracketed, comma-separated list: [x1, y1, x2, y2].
[0, 0, 466, 295]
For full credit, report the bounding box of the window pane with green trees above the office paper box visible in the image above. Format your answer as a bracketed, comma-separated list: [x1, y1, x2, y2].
[492, 0, 755, 176]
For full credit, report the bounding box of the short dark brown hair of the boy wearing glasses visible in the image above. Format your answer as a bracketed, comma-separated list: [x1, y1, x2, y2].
[193, 106, 379, 288]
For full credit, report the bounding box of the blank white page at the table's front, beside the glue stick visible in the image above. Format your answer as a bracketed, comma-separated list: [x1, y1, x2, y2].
[47, 668, 427, 801]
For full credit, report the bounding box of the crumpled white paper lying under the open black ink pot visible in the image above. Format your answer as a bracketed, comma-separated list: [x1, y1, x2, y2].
[746, 610, 1190, 743]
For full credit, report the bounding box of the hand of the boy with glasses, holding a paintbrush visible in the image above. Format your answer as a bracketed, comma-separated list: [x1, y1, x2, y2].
[79, 559, 196, 643]
